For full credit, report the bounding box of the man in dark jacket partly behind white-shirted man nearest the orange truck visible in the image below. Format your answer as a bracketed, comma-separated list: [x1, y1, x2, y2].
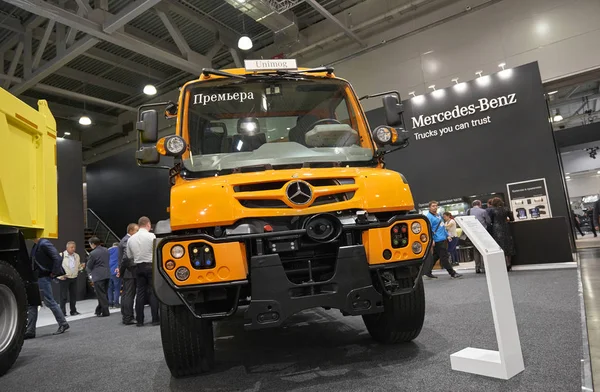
[118, 223, 139, 325]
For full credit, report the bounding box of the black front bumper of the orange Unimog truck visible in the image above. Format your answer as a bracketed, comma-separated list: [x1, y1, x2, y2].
[153, 216, 431, 329]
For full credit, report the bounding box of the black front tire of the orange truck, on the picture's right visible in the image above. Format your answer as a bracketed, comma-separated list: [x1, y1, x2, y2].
[363, 279, 425, 344]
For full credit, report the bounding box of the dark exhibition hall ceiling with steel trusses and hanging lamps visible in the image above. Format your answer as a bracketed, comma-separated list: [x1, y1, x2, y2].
[0, 0, 446, 150]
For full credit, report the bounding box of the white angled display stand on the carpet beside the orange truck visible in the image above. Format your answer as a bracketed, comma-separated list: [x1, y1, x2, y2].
[450, 216, 525, 380]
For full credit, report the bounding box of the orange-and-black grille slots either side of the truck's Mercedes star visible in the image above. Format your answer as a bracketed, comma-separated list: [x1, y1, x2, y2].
[233, 178, 358, 208]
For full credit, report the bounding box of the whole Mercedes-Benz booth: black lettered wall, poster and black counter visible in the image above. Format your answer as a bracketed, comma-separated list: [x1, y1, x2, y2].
[367, 63, 573, 265]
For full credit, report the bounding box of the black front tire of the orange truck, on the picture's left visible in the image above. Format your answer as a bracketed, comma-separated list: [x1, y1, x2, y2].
[160, 303, 215, 378]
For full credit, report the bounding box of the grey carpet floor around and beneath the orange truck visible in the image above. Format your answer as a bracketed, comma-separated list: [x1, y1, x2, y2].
[0, 270, 582, 392]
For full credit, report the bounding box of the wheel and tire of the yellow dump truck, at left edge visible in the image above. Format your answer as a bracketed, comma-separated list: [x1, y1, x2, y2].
[0, 260, 27, 376]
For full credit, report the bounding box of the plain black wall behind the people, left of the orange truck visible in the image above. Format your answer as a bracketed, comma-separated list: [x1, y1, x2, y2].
[86, 150, 171, 236]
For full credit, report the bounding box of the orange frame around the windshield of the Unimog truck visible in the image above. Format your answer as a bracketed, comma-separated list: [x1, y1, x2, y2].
[176, 73, 377, 171]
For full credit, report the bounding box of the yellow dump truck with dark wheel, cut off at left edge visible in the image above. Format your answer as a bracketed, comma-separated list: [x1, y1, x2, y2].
[0, 88, 58, 376]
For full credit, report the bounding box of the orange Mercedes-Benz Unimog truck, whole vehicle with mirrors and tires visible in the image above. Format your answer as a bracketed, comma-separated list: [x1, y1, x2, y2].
[136, 59, 431, 377]
